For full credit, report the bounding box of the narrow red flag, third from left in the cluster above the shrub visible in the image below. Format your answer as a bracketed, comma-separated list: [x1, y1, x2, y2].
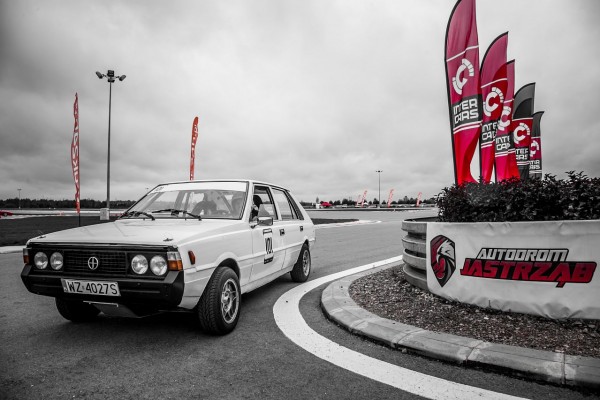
[494, 60, 520, 182]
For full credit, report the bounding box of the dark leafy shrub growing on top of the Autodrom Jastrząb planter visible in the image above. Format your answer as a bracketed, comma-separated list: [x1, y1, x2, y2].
[437, 171, 600, 222]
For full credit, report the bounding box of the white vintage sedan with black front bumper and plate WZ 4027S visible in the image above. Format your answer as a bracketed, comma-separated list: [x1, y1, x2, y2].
[21, 180, 315, 334]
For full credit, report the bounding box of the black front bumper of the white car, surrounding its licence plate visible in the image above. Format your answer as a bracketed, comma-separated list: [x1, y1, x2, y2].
[21, 264, 184, 311]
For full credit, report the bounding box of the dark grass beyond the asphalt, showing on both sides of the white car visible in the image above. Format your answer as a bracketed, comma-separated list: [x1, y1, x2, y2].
[0, 215, 357, 246]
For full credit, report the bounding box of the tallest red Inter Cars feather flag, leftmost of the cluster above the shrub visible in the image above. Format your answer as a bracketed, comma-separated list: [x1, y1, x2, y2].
[445, 0, 481, 184]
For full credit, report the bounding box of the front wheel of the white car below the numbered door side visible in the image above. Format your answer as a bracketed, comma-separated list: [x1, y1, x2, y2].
[197, 267, 242, 335]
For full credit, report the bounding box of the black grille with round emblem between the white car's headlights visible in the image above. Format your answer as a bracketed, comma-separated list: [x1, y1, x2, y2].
[64, 250, 127, 275]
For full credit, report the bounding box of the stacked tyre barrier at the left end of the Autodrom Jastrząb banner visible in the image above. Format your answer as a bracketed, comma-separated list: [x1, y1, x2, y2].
[402, 217, 437, 291]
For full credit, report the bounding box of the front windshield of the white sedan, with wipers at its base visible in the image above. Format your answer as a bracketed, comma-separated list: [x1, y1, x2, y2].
[123, 181, 248, 220]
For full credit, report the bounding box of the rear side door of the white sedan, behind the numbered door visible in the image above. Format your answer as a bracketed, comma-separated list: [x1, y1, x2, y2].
[272, 188, 304, 268]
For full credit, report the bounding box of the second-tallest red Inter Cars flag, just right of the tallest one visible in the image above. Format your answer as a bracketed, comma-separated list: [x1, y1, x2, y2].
[479, 33, 508, 183]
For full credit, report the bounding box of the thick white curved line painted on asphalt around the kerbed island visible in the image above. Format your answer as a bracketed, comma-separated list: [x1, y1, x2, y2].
[273, 256, 520, 400]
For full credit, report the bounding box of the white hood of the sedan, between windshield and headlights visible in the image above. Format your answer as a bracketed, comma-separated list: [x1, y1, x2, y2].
[28, 219, 248, 246]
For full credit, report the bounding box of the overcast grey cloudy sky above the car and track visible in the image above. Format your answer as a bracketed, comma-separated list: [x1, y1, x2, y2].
[0, 0, 600, 205]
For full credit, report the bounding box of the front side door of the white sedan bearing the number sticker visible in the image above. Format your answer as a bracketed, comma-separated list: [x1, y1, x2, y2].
[250, 185, 285, 281]
